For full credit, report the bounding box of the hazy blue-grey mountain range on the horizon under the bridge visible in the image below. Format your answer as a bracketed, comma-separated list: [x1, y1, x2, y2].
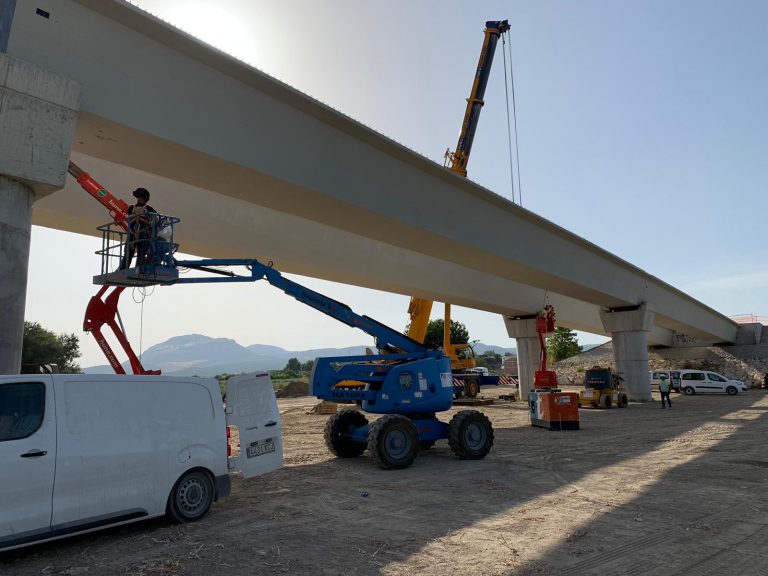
[84, 334, 528, 376]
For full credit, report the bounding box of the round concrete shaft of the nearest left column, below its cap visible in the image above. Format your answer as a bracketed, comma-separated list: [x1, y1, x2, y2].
[0, 175, 34, 374]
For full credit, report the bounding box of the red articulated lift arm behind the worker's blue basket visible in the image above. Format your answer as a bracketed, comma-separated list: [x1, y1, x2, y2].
[69, 162, 160, 376]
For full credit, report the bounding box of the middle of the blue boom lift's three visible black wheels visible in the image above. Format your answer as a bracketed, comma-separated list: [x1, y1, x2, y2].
[368, 414, 420, 470]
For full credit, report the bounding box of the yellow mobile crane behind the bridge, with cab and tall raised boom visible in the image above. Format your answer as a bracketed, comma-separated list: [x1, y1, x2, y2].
[408, 20, 509, 398]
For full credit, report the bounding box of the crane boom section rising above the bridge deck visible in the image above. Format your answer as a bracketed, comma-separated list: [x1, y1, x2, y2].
[446, 20, 509, 176]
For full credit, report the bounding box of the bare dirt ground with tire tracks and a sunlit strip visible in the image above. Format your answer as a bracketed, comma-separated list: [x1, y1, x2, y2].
[0, 382, 768, 576]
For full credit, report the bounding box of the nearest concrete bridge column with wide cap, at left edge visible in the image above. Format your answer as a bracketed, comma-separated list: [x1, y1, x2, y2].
[0, 53, 80, 374]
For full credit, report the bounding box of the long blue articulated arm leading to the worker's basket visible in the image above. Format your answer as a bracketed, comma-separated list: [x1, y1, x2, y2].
[175, 259, 427, 353]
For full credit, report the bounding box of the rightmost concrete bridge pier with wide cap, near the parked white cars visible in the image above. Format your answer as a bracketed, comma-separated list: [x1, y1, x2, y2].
[600, 304, 654, 402]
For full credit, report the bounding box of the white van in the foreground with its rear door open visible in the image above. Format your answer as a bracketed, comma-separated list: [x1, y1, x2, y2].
[0, 374, 283, 550]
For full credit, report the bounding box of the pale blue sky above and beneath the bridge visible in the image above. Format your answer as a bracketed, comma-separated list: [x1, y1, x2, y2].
[27, 0, 768, 365]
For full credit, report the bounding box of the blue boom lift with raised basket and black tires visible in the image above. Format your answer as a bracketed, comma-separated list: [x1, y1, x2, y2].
[94, 215, 493, 469]
